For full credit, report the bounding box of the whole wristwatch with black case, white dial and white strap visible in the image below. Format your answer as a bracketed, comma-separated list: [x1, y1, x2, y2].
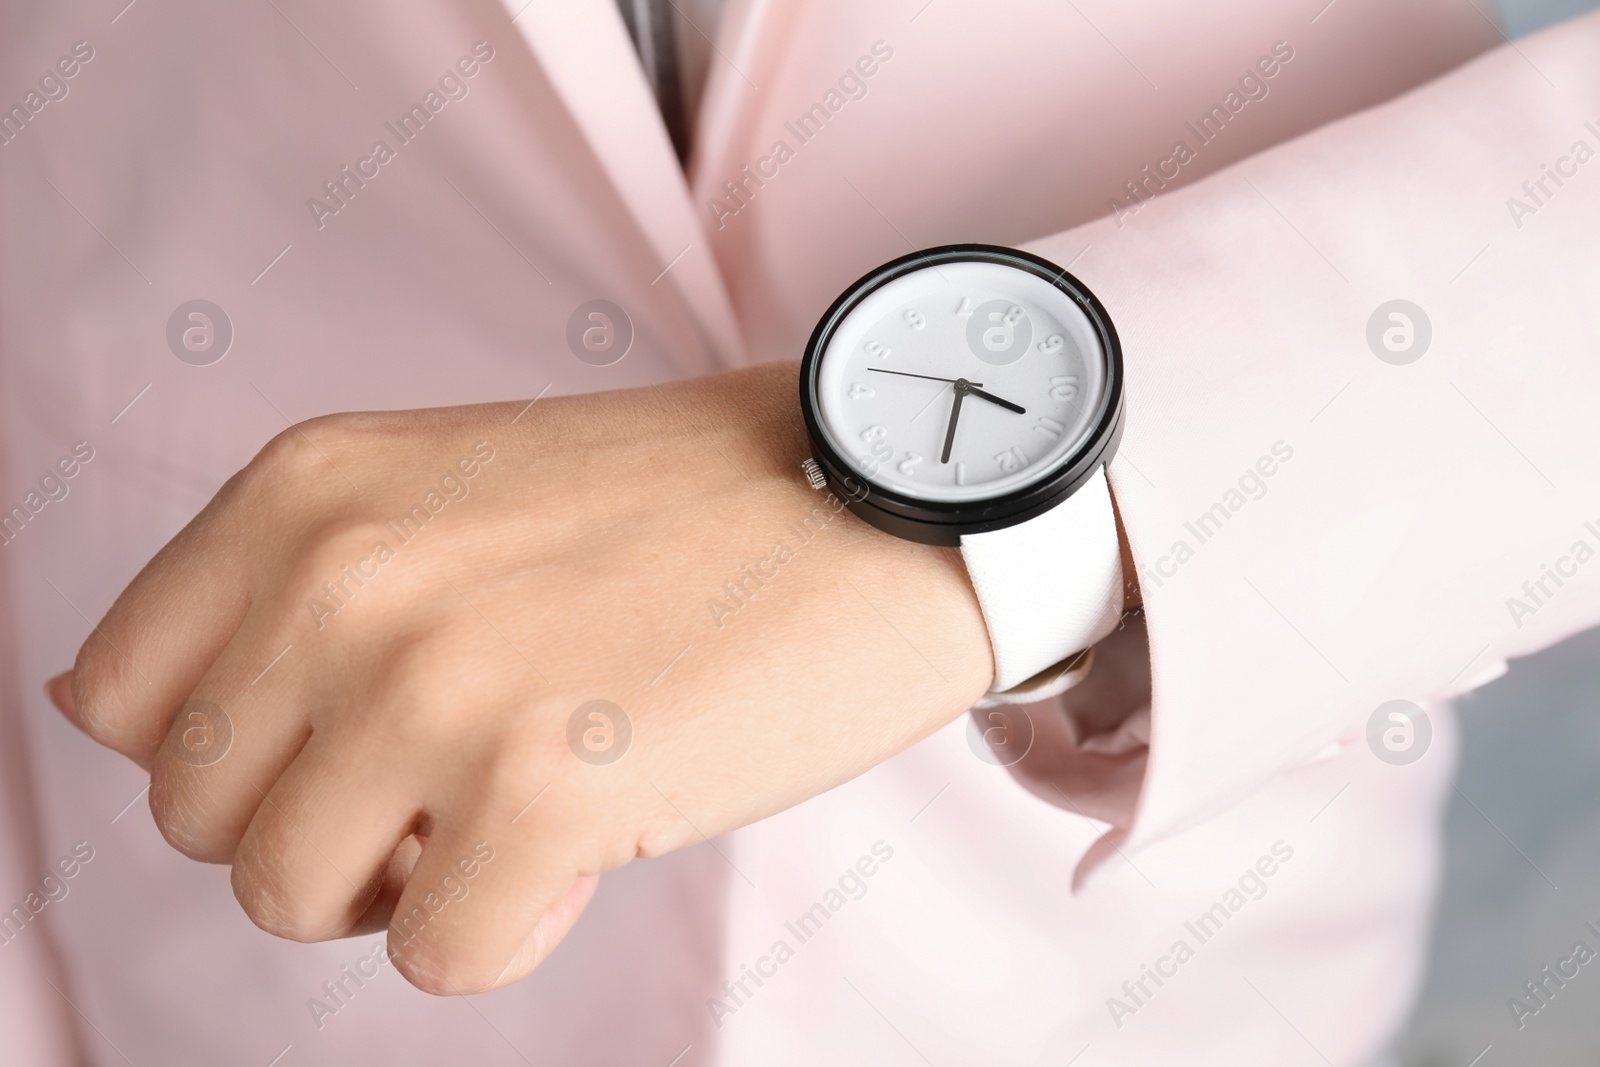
[800, 245, 1123, 702]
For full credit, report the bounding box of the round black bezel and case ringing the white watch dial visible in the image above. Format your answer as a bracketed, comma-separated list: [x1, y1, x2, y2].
[800, 245, 1123, 545]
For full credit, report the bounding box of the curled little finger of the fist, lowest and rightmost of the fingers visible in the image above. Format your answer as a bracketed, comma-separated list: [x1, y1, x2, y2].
[389, 785, 598, 997]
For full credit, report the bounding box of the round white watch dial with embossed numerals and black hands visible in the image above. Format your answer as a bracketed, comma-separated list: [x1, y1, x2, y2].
[816, 261, 1107, 502]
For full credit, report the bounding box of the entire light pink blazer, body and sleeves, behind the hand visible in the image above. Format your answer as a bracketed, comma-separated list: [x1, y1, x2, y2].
[0, 0, 1600, 1067]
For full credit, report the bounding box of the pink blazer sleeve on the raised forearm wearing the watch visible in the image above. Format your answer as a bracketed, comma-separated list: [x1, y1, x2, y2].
[1011, 14, 1600, 848]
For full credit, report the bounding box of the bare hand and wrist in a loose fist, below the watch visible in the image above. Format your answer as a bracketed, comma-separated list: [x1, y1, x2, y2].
[51, 363, 992, 993]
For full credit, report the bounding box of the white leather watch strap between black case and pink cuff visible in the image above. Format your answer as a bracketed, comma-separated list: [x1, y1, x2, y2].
[962, 467, 1122, 699]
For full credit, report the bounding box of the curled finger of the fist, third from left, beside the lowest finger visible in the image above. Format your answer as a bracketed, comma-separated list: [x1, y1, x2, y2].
[234, 731, 419, 941]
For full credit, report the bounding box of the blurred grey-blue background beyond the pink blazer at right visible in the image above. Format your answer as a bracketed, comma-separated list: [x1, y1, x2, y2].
[1395, 0, 1600, 1067]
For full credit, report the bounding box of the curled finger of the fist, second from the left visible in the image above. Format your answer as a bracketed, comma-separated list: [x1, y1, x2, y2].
[150, 611, 313, 864]
